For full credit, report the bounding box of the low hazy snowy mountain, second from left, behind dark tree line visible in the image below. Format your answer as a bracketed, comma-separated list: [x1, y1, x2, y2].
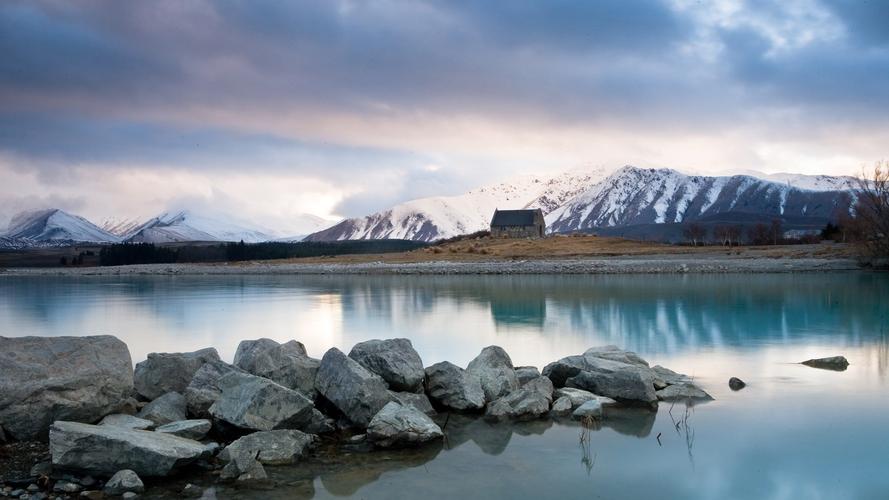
[125, 211, 274, 243]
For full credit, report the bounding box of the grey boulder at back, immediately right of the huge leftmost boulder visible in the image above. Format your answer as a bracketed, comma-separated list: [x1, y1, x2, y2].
[133, 347, 219, 400]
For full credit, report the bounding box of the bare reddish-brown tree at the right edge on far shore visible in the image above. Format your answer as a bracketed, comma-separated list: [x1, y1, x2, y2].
[855, 161, 889, 259]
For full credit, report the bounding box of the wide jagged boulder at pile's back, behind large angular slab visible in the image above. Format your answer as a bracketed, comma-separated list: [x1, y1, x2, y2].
[234, 338, 321, 399]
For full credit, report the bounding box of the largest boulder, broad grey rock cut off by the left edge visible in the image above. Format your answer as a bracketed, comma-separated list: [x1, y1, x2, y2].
[0, 335, 133, 440]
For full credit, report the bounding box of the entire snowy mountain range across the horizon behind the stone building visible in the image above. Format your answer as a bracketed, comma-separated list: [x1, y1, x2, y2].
[0, 166, 856, 248]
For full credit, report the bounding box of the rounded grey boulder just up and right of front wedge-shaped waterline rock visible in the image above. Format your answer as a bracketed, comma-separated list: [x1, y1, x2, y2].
[426, 361, 485, 411]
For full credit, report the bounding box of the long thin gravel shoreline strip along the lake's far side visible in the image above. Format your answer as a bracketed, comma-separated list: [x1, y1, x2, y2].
[0, 254, 861, 277]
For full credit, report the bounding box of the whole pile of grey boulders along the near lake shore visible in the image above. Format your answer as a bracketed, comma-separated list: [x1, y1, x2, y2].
[0, 336, 712, 500]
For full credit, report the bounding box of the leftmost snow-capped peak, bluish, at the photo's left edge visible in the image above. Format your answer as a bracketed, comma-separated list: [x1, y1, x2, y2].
[3, 208, 121, 246]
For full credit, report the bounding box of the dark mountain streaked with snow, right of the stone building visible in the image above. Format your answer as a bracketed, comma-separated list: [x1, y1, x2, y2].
[547, 166, 851, 232]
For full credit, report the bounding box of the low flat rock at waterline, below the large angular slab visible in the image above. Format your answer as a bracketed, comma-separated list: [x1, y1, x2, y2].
[219, 430, 315, 465]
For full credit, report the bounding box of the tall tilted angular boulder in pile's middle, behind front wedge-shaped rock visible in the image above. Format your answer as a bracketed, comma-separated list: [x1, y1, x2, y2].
[315, 348, 389, 427]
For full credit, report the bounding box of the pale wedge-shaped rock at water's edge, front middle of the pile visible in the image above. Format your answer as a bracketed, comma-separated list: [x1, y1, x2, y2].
[367, 401, 444, 448]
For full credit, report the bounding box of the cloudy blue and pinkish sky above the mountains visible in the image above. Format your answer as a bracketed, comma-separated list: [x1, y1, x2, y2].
[0, 0, 889, 232]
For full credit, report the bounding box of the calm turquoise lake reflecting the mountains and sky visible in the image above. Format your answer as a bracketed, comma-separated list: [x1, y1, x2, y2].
[0, 272, 889, 499]
